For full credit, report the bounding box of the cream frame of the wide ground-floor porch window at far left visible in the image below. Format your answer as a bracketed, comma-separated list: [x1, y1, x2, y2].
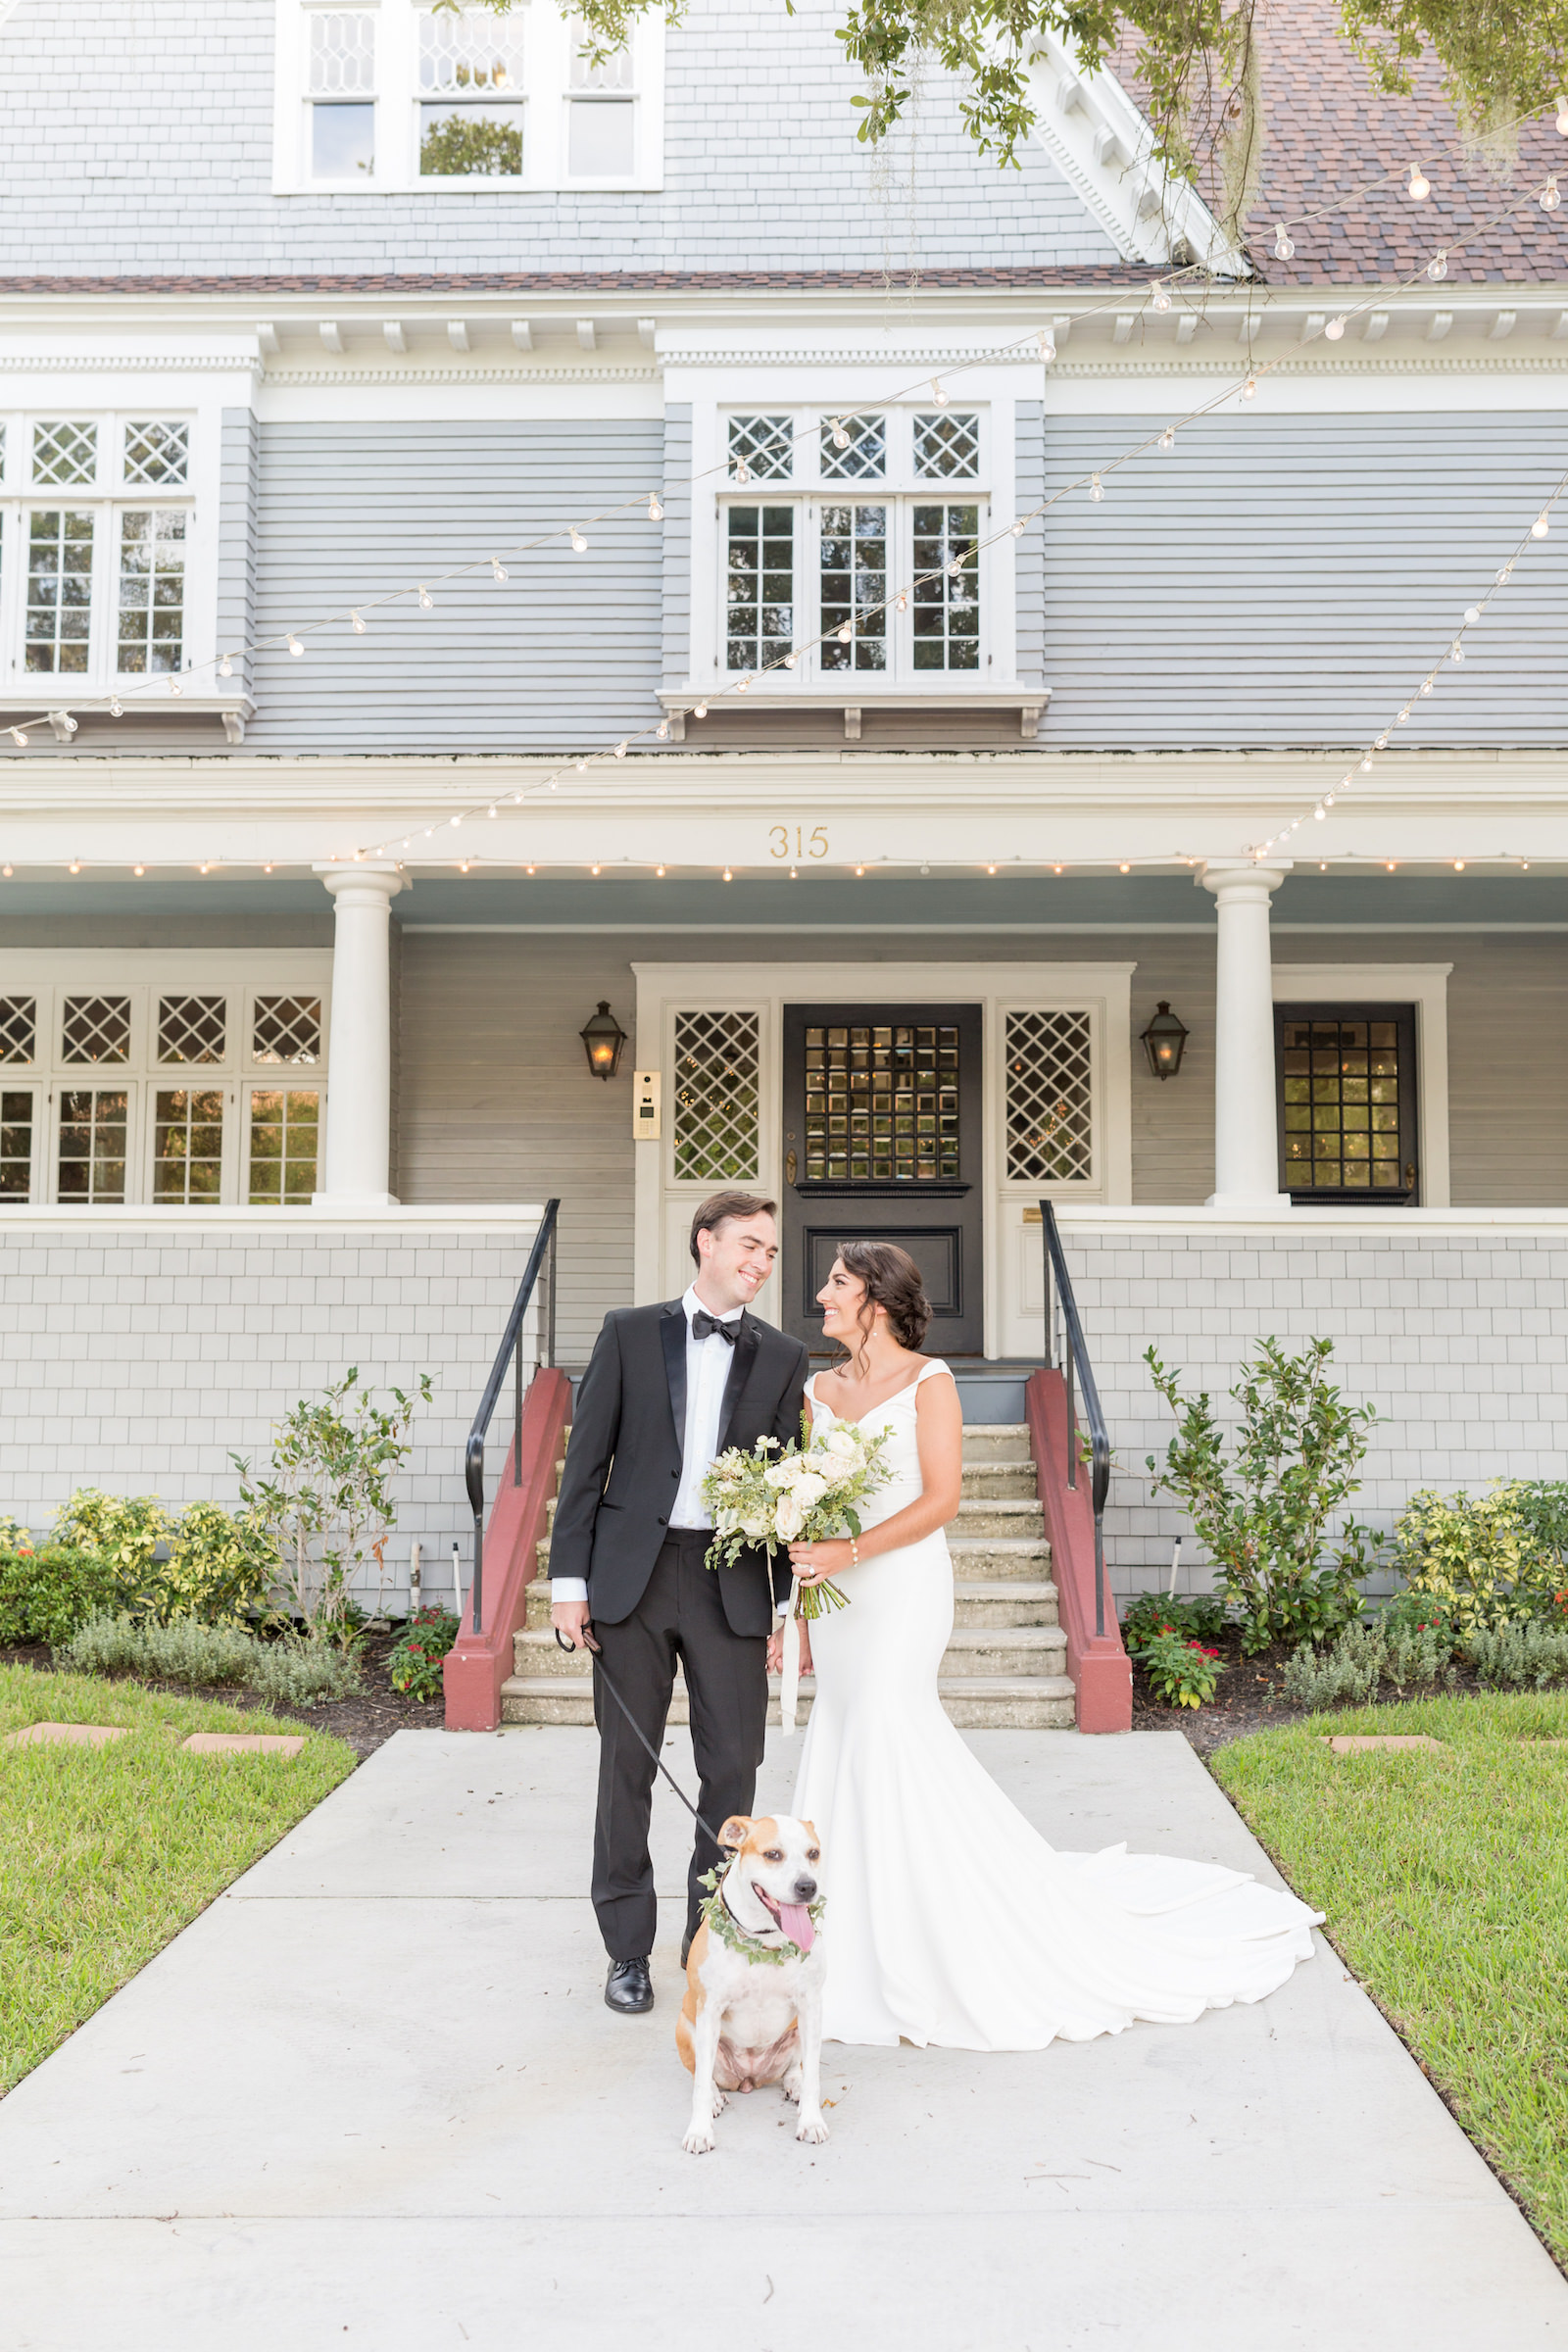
[0, 948, 331, 1221]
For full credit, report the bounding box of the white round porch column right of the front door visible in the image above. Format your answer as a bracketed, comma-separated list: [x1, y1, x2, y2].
[1199, 858, 1291, 1209]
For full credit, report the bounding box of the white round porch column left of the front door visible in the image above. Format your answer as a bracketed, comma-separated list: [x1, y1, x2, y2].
[315, 865, 405, 1209]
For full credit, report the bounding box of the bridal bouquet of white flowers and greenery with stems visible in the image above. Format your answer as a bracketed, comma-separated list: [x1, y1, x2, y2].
[703, 1418, 891, 1618]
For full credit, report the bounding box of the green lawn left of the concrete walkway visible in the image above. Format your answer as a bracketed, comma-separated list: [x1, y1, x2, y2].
[0, 1665, 355, 2093]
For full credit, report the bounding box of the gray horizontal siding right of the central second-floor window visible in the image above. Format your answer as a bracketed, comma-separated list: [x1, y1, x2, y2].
[1042, 410, 1568, 751]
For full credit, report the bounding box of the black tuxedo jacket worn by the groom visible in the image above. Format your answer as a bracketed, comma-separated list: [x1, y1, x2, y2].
[550, 1298, 808, 1635]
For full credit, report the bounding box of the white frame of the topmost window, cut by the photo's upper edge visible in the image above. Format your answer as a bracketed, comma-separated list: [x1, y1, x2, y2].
[272, 0, 665, 200]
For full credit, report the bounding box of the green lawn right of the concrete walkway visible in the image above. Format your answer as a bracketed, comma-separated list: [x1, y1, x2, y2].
[1210, 1693, 1568, 2260]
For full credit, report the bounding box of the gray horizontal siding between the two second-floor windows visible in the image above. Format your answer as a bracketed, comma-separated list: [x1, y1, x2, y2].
[247, 418, 662, 753]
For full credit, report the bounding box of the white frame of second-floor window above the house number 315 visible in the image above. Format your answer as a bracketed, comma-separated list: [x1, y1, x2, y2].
[676, 385, 1029, 708]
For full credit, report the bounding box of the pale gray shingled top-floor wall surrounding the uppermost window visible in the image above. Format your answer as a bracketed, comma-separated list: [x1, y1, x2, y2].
[0, 0, 1116, 277]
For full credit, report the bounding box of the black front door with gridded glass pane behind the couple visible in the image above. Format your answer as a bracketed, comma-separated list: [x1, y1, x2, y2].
[783, 1004, 985, 1354]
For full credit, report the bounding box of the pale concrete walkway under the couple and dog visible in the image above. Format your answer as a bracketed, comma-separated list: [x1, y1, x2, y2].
[0, 1729, 1568, 2352]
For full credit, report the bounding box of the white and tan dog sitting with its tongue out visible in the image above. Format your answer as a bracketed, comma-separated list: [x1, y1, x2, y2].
[674, 1813, 827, 2157]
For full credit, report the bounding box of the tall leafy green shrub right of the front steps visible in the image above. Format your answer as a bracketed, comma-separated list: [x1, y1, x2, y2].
[1145, 1339, 1382, 1653]
